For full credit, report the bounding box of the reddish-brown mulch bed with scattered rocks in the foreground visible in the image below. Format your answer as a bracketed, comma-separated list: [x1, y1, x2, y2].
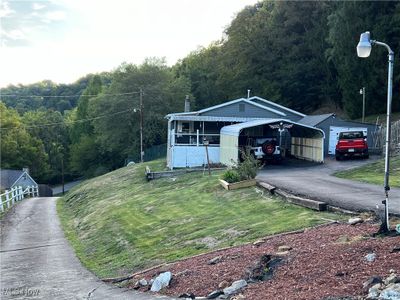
[130, 223, 400, 300]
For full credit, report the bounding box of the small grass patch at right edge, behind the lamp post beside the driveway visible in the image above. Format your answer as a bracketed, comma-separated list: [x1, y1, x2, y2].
[334, 156, 400, 187]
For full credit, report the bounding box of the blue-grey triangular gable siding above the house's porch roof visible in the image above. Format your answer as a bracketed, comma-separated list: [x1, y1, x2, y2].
[201, 102, 287, 119]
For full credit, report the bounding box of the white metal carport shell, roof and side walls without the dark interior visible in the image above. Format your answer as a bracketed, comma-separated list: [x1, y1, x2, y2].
[220, 119, 325, 166]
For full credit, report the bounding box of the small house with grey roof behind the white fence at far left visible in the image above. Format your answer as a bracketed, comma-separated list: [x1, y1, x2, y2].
[0, 168, 38, 190]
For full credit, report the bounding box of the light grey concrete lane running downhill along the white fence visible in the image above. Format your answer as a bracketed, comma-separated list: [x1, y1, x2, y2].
[0, 198, 173, 300]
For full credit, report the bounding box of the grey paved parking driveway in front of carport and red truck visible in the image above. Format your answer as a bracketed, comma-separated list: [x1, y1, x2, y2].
[257, 157, 400, 215]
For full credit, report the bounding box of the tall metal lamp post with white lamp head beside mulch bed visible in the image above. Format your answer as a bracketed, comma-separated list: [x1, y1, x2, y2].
[357, 31, 394, 232]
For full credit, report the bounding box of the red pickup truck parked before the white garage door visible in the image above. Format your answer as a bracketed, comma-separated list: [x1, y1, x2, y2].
[335, 131, 369, 160]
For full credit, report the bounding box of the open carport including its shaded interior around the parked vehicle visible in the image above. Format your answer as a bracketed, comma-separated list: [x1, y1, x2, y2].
[220, 119, 325, 166]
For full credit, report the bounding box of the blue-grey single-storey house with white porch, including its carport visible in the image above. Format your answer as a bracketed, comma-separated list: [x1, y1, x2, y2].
[166, 96, 376, 169]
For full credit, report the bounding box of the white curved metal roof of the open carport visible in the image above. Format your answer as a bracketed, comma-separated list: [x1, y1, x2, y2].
[221, 119, 325, 137]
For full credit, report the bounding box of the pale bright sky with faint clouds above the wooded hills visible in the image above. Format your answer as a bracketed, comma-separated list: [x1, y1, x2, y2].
[0, 0, 257, 87]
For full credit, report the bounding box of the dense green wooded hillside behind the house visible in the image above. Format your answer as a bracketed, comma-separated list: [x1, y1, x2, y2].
[0, 1, 400, 184]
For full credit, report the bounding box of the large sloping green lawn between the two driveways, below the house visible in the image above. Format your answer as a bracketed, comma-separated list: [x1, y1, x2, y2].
[57, 160, 342, 278]
